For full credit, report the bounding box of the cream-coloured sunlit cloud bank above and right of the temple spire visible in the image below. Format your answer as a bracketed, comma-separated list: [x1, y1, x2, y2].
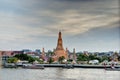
[40, 10, 119, 35]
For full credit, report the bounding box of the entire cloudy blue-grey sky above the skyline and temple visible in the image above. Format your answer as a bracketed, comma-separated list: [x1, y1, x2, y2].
[0, 0, 120, 52]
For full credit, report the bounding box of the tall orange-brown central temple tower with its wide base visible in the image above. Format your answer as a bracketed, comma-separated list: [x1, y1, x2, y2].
[54, 32, 68, 60]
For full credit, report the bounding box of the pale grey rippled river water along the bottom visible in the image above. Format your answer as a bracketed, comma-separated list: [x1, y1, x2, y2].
[0, 68, 120, 80]
